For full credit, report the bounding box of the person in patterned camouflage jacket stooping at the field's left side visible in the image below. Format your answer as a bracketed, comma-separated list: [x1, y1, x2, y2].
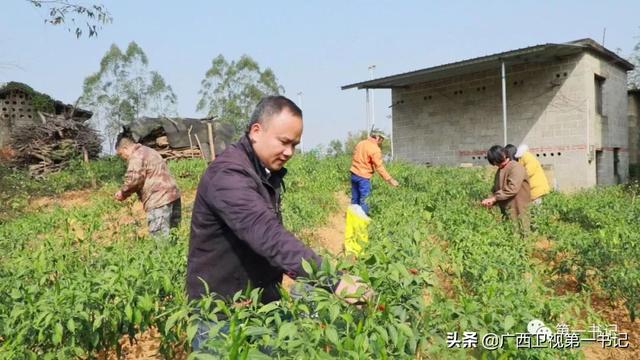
[114, 137, 181, 238]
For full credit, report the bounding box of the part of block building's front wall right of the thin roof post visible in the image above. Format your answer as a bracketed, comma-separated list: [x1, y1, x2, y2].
[507, 55, 595, 190]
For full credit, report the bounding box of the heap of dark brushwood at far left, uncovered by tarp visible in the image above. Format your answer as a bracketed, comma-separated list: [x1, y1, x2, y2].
[11, 114, 102, 176]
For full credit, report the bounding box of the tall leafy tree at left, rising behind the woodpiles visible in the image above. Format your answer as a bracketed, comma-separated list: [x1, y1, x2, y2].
[79, 42, 177, 148]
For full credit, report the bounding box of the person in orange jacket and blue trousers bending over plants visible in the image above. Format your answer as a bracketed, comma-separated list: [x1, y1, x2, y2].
[350, 131, 399, 215]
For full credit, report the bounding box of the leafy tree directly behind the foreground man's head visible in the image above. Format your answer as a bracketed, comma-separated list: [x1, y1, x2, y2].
[196, 55, 284, 138]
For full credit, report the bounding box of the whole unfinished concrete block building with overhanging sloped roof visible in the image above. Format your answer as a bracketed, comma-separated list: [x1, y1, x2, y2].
[343, 39, 633, 190]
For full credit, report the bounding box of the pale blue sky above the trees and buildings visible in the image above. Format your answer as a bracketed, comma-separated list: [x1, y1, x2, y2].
[0, 0, 640, 148]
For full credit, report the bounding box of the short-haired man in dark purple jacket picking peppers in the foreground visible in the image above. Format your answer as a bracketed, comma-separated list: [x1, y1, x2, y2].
[187, 96, 370, 318]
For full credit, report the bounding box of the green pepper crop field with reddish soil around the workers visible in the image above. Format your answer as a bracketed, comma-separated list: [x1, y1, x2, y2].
[0, 155, 640, 359]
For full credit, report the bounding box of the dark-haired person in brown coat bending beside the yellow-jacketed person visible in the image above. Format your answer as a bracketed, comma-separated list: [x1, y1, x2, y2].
[481, 145, 531, 235]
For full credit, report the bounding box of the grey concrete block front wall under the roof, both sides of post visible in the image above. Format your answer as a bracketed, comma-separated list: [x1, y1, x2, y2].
[392, 55, 595, 189]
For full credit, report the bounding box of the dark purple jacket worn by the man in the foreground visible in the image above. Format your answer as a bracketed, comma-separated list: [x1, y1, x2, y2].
[187, 136, 320, 303]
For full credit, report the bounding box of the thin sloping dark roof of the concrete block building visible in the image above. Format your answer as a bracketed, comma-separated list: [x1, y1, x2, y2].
[342, 39, 633, 90]
